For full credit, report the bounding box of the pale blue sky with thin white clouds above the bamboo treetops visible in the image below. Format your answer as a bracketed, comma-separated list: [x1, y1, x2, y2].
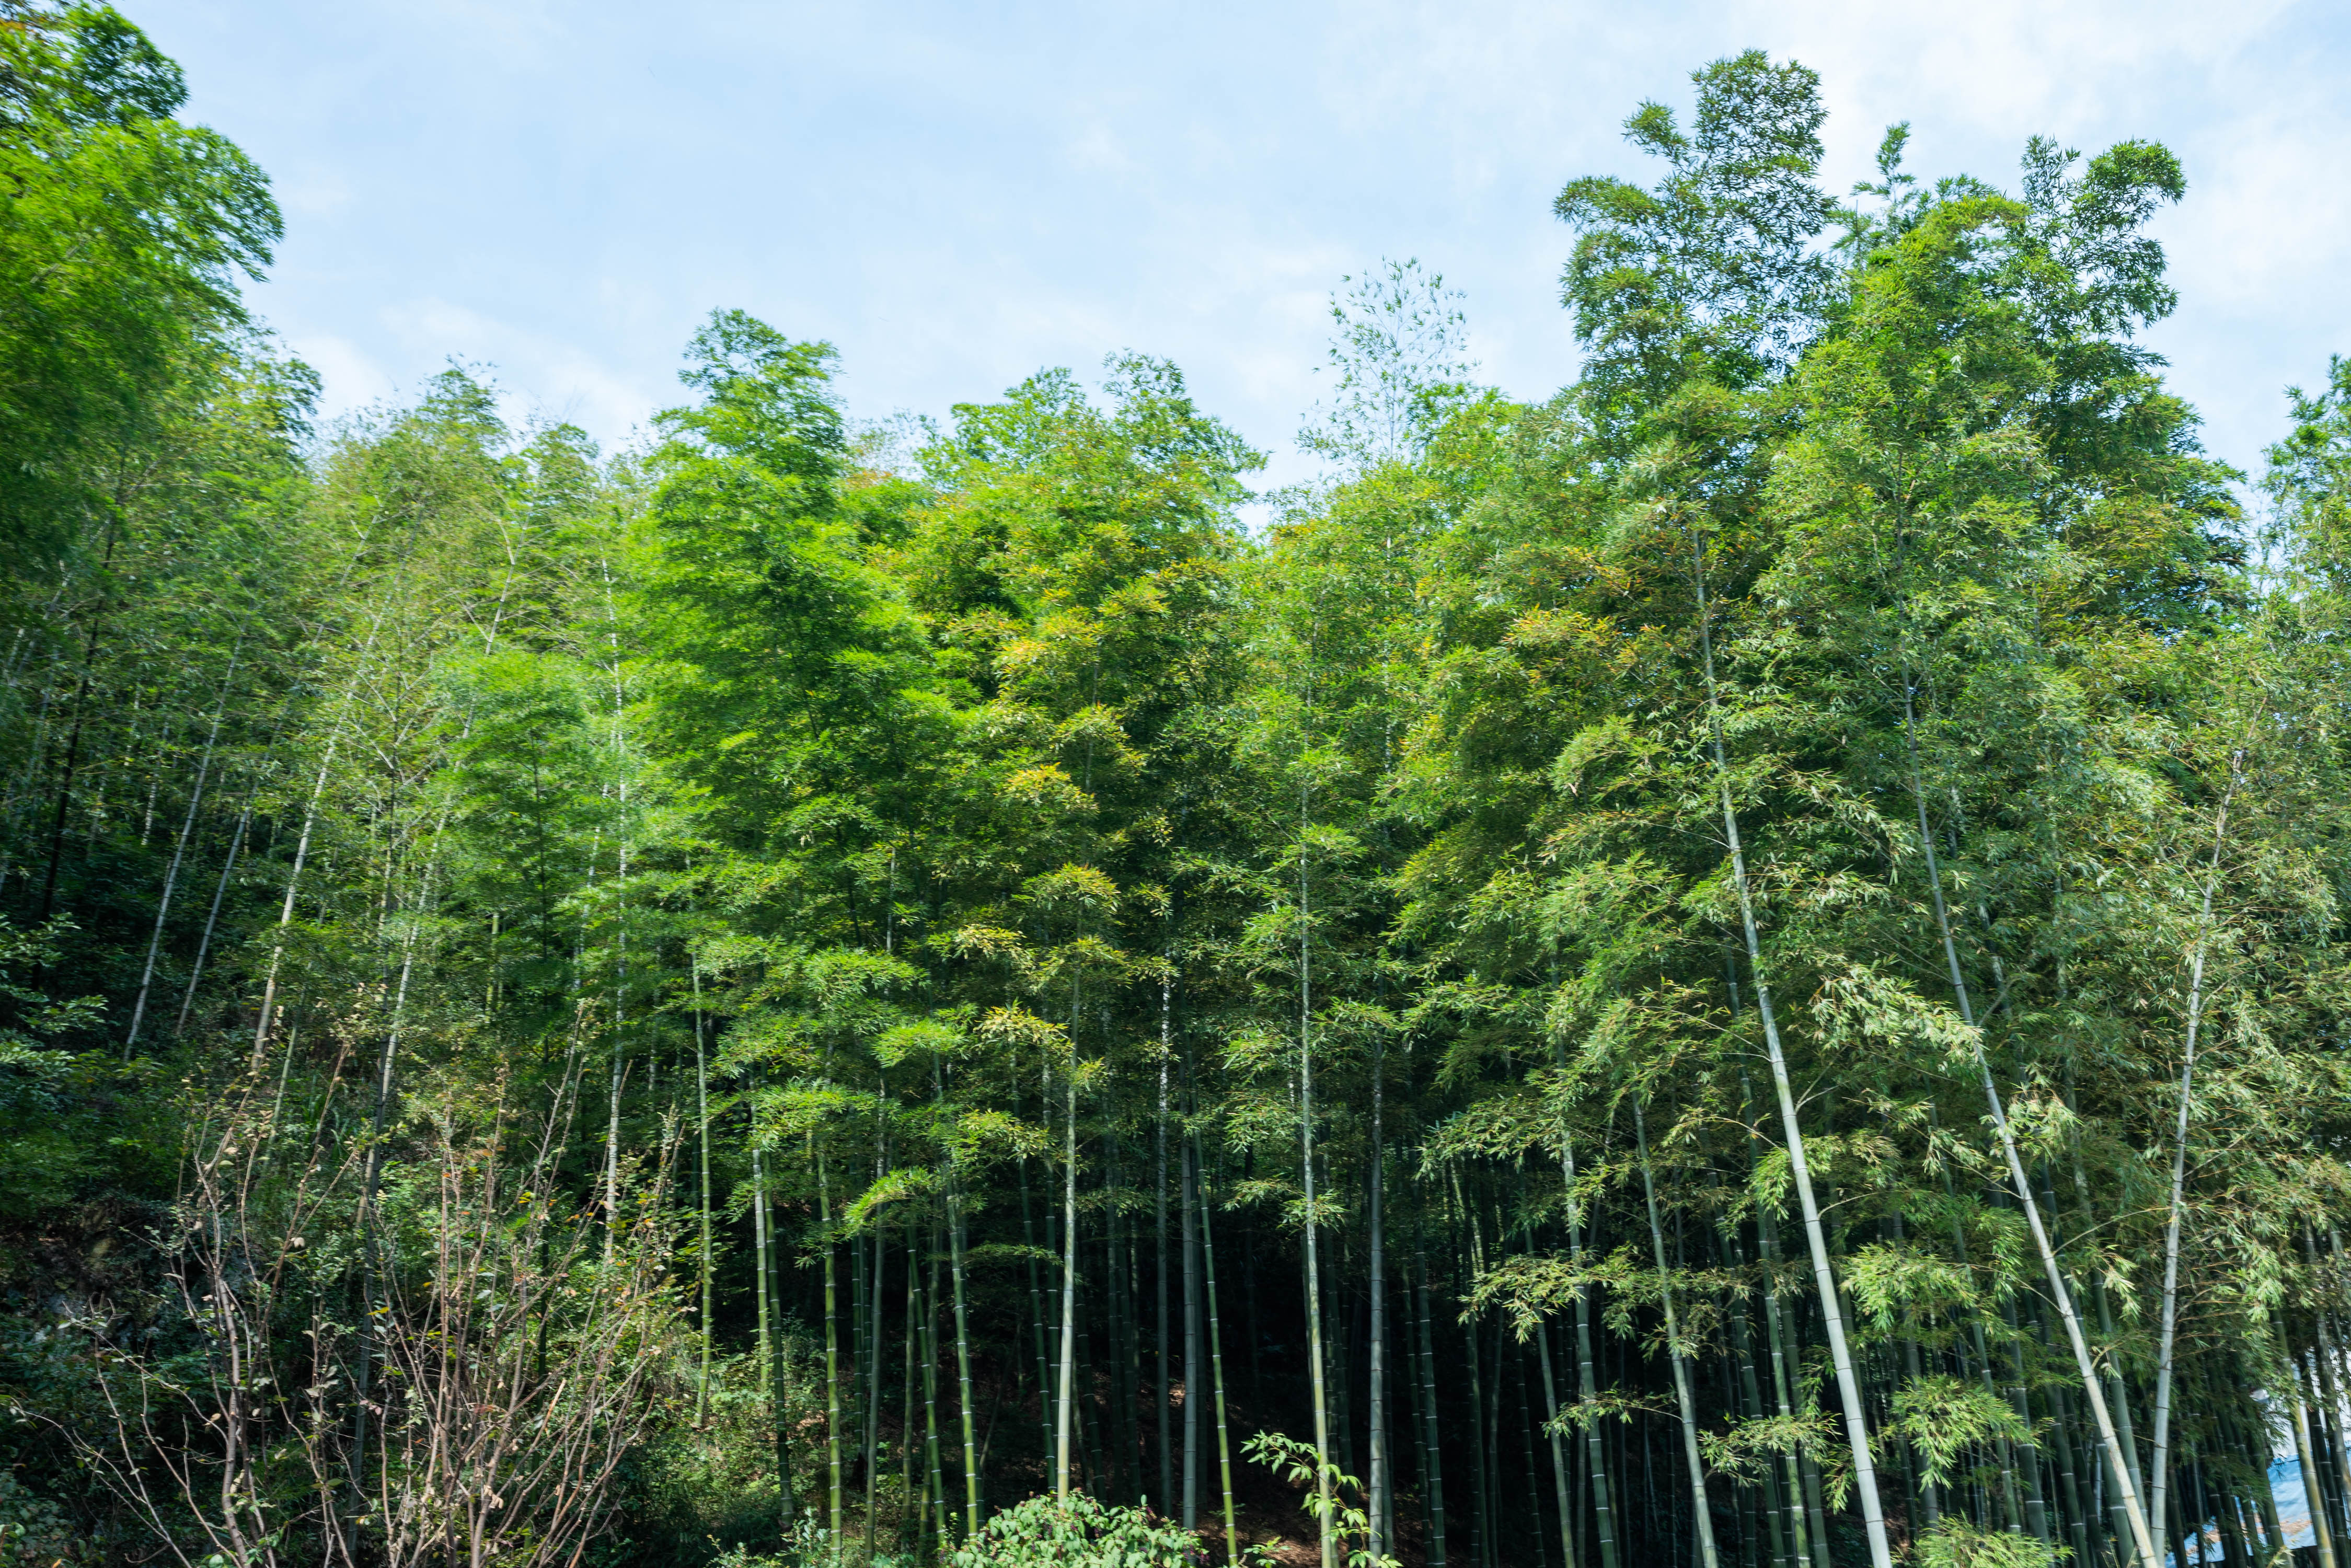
[142, 0, 2351, 496]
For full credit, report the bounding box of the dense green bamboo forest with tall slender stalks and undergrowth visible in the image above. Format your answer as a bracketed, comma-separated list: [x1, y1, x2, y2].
[14, 0, 2351, 1568]
